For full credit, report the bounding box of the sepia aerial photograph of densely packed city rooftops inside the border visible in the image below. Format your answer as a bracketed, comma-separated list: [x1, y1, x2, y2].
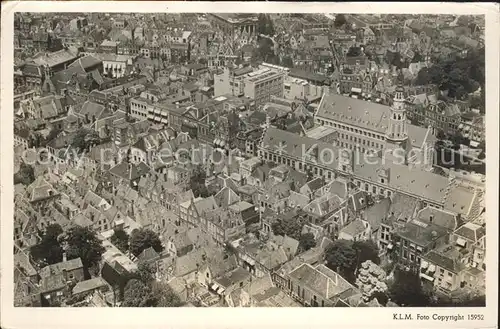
[13, 12, 486, 308]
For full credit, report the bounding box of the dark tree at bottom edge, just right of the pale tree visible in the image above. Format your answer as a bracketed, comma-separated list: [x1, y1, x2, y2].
[389, 268, 430, 307]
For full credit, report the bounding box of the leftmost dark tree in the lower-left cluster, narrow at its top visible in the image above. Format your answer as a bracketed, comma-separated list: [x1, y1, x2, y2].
[30, 224, 64, 266]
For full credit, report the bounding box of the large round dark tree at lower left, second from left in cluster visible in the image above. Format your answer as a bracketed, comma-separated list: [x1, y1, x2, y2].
[65, 226, 105, 271]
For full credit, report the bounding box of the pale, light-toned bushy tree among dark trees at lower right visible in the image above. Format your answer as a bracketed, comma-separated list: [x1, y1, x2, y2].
[356, 260, 388, 302]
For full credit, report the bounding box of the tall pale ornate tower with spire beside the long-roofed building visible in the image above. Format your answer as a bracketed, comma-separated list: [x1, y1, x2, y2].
[386, 85, 408, 145]
